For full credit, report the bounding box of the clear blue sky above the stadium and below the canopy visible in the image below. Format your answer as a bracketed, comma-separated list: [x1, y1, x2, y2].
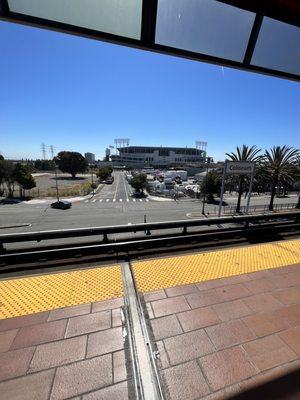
[0, 18, 300, 160]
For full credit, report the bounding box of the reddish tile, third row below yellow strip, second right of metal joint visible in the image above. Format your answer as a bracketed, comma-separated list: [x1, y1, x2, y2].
[177, 307, 220, 332]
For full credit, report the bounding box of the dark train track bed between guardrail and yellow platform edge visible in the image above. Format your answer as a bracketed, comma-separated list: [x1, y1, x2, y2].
[0, 221, 300, 275]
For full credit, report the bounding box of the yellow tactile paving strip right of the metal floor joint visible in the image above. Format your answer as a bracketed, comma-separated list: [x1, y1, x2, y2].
[133, 240, 300, 292]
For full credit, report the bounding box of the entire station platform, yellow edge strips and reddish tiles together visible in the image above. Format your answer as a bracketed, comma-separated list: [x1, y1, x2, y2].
[0, 240, 300, 400]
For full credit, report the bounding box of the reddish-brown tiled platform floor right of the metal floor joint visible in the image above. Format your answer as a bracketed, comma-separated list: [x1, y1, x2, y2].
[144, 264, 300, 400]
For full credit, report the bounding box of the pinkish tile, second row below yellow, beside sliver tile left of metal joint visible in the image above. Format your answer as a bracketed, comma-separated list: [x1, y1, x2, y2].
[66, 310, 111, 337]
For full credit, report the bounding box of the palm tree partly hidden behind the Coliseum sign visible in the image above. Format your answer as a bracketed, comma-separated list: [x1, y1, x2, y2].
[226, 144, 261, 213]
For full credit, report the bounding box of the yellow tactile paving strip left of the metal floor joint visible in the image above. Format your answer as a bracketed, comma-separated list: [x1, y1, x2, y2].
[0, 266, 123, 319]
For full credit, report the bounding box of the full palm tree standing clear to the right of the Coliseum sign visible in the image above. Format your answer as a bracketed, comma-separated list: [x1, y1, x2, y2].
[262, 146, 300, 211]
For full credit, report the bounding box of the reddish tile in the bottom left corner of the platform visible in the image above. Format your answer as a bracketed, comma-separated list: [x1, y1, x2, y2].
[0, 370, 55, 400]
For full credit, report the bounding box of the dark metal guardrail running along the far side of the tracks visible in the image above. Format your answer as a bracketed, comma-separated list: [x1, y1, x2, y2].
[0, 211, 300, 251]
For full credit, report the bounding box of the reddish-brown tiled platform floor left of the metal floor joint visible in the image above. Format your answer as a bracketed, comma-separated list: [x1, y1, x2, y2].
[0, 298, 128, 400]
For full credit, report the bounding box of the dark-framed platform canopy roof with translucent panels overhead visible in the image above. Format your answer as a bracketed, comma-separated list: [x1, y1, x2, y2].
[0, 0, 300, 81]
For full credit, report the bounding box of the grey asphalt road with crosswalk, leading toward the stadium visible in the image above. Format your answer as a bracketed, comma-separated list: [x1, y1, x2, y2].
[0, 172, 297, 233]
